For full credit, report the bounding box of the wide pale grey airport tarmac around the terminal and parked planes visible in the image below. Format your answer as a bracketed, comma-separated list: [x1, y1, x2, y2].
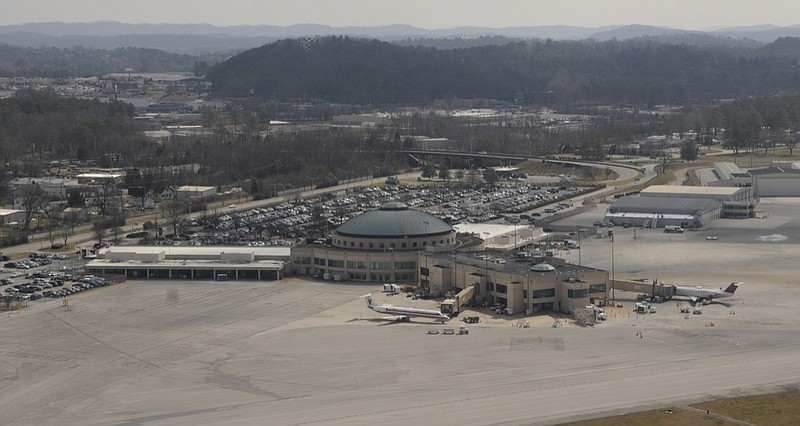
[0, 203, 800, 425]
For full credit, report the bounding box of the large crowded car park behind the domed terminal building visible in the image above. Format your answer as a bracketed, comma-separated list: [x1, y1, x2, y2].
[145, 180, 593, 246]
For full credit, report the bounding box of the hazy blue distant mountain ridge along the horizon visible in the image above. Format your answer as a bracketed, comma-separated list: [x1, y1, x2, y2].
[0, 21, 800, 55]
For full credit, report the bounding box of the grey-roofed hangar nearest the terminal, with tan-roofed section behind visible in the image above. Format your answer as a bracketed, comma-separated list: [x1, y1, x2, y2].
[605, 185, 756, 228]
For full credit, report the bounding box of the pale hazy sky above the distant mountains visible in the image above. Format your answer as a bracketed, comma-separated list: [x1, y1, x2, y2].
[0, 0, 800, 29]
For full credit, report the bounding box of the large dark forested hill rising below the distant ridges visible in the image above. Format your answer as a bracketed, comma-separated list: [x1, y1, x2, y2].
[207, 37, 800, 104]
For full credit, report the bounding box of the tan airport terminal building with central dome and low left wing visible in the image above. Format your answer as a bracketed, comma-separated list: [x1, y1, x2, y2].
[85, 202, 608, 314]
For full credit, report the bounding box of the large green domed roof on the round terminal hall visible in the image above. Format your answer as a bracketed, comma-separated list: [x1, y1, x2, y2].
[336, 202, 453, 238]
